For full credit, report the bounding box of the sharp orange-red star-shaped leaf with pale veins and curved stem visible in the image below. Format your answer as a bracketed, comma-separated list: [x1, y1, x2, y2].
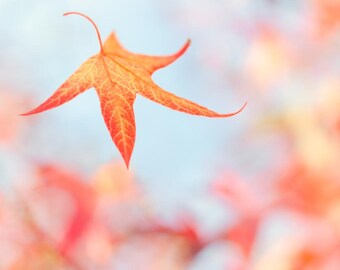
[22, 12, 246, 167]
